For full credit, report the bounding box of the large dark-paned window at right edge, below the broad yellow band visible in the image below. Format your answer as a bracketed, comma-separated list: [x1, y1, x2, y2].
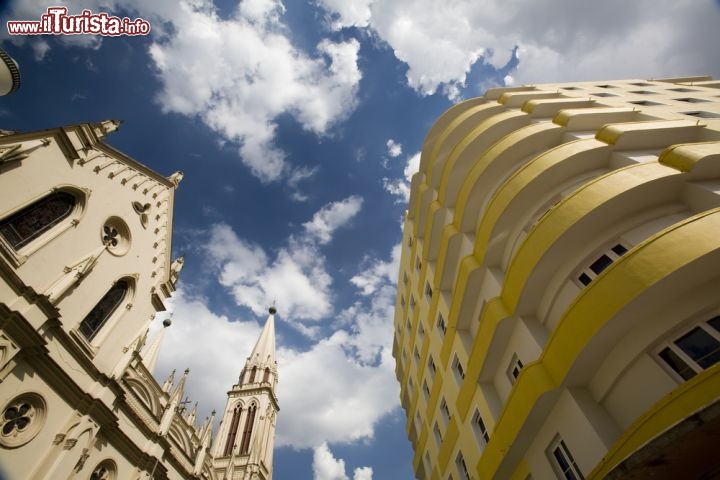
[658, 315, 720, 380]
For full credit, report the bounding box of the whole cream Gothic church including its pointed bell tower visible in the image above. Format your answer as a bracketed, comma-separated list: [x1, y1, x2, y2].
[0, 121, 279, 480]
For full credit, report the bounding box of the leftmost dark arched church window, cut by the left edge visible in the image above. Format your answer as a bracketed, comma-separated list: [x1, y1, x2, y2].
[0, 192, 77, 250]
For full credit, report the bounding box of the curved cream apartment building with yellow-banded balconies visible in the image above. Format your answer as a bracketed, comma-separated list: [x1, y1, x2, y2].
[393, 77, 720, 480]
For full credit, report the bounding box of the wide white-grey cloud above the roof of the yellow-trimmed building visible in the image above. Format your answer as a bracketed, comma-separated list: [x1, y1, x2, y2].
[319, 0, 720, 99]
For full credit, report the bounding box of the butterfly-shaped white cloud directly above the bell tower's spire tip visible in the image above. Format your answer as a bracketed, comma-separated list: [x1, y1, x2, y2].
[206, 195, 362, 322]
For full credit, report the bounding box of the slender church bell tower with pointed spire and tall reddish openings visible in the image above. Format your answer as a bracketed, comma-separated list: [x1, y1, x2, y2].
[213, 307, 280, 480]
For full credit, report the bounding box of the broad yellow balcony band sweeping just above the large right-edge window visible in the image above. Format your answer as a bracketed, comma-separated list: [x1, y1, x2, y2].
[476, 208, 720, 478]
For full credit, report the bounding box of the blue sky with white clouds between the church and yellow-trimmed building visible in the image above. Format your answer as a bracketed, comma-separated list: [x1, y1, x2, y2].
[0, 0, 720, 480]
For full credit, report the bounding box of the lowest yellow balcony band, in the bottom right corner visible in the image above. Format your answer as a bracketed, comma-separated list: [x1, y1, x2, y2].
[587, 365, 720, 480]
